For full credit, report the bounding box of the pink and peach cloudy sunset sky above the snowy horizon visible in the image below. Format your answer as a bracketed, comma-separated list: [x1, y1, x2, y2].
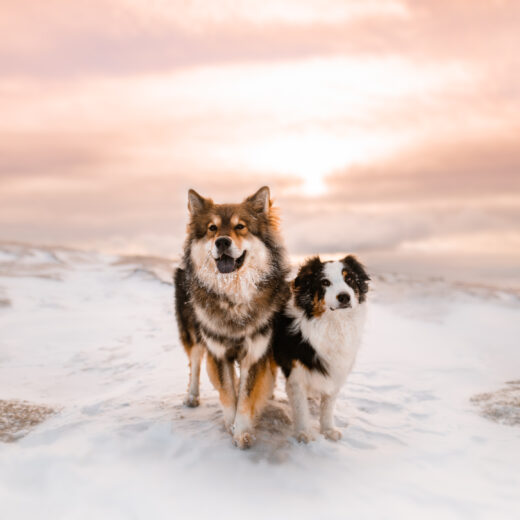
[0, 0, 520, 287]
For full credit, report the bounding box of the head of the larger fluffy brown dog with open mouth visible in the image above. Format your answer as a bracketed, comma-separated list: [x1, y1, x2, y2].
[188, 186, 282, 296]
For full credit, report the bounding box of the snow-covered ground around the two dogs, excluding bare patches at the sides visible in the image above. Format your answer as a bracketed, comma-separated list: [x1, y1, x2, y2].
[0, 244, 520, 520]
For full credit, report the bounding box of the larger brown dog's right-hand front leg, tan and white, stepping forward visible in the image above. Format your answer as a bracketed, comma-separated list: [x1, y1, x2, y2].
[233, 354, 274, 449]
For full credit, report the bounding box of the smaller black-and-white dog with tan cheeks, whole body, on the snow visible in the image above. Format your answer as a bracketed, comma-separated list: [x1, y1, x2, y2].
[272, 255, 370, 442]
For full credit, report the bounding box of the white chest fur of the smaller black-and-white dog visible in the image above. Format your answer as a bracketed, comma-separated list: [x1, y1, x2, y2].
[298, 303, 366, 395]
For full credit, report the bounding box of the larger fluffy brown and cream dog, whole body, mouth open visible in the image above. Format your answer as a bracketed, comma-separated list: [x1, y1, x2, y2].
[175, 187, 289, 448]
